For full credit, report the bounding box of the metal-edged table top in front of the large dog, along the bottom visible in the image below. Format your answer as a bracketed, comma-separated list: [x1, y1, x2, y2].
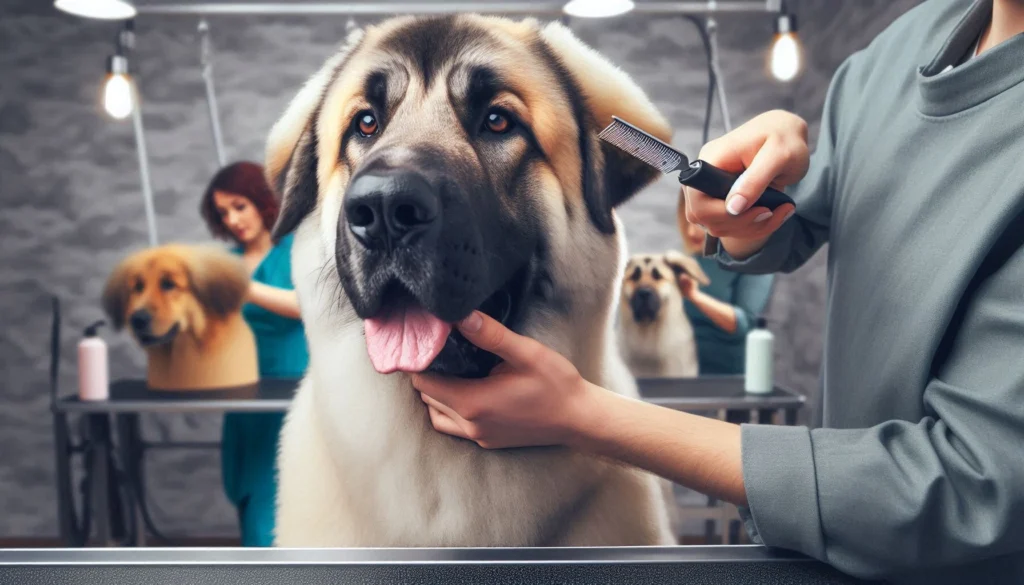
[0, 546, 861, 585]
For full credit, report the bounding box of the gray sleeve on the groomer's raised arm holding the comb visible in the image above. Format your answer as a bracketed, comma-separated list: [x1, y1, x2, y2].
[712, 57, 856, 274]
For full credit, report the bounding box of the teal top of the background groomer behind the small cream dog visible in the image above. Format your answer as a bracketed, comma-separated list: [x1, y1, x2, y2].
[683, 256, 774, 375]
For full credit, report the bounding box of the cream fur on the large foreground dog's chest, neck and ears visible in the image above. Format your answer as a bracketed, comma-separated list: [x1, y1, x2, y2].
[267, 18, 676, 547]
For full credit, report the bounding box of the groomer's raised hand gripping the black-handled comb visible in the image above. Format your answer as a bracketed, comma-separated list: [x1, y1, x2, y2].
[680, 111, 810, 258]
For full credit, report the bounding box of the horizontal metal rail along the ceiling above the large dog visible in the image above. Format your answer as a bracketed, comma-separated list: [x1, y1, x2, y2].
[136, 0, 772, 15]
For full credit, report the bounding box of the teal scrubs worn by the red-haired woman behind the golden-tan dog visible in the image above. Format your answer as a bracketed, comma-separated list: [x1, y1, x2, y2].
[221, 235, 309, 546]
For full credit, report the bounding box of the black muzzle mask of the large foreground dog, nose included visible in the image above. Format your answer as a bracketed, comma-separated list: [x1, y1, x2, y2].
[335, 148, 539, 377]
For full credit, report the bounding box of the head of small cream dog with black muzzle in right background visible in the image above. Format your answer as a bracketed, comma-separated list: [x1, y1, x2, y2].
[620, 251, 711, 325]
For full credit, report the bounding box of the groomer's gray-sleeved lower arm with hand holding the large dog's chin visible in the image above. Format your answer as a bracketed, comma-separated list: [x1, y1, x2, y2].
[413, 297, 1024, 578]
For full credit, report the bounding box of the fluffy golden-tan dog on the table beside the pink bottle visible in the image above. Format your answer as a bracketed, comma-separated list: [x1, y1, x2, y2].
[103, 244, 259, 390]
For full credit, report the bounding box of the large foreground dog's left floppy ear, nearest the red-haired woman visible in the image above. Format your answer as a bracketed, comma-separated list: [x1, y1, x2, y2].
[264, 29, 364, 242]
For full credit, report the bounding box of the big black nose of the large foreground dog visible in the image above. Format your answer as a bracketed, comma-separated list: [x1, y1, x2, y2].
[345, 171, 441, 250]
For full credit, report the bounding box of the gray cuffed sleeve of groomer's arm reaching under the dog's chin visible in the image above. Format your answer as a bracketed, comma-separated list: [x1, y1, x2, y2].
[742, 245, 1024, 578]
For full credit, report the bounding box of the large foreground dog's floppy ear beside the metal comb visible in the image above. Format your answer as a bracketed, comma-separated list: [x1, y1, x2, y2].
[541, 22, 672, 233]
